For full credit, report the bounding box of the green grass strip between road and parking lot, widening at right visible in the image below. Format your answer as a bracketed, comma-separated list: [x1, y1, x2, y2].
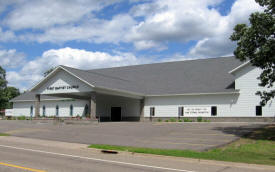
[89, 125, 275, 165]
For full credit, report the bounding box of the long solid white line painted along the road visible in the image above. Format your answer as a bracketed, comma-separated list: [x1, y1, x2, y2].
[0, 145, 195, 172]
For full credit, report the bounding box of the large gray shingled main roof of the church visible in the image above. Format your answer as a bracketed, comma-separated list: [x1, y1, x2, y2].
[11, 57, 242, 101]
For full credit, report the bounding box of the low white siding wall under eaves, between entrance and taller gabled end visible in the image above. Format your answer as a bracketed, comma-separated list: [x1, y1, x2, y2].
[144, 94, 238, 117]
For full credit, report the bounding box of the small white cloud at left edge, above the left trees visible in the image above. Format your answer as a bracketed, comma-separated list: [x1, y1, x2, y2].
[0, 49, 25, 68]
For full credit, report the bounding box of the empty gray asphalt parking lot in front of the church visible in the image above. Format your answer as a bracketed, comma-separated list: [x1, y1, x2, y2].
[0, 120, 265, 150]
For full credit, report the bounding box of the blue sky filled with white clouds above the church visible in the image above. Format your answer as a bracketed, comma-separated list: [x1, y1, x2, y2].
[0, 0, 262, 91]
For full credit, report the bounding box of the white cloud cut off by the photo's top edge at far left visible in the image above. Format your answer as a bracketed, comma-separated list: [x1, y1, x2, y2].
[4, 0, 118, 30]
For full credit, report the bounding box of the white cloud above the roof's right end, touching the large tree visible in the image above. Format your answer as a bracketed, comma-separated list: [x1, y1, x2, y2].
[187, 0, 262, 58]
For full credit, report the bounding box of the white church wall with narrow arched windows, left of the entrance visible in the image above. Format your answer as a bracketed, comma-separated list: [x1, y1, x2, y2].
[13, 100, 89, 117]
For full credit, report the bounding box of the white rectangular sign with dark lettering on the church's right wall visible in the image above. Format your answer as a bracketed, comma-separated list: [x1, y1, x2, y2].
[184, 107, 211, 117]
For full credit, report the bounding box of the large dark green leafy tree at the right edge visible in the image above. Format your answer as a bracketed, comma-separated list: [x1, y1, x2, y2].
[230, 0, 275, 106]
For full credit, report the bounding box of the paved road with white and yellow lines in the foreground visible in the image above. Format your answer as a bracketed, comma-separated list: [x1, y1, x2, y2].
[0, 136, 275, 172]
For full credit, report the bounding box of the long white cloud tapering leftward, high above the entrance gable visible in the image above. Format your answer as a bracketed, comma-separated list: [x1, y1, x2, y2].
[20, 15, 135, 44]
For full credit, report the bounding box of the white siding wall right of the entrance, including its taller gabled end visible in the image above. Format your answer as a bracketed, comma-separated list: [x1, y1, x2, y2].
[144, 66, 275, 117]
